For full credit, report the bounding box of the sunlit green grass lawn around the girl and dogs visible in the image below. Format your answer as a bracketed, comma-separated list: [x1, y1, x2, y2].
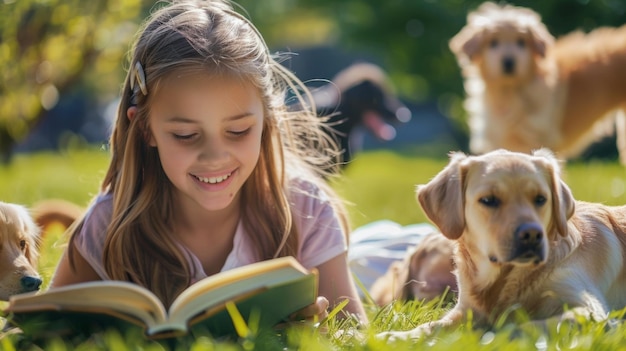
[0, 149, 626, 351]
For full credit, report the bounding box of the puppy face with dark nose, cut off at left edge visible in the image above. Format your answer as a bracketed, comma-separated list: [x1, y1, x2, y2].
[0, 202, 42, 301]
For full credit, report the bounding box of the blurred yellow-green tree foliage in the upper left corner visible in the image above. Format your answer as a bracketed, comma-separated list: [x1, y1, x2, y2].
[0, 0, 141, 161]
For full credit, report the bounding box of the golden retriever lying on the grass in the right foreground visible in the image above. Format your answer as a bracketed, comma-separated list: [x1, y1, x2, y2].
[381, 149, 626, 338]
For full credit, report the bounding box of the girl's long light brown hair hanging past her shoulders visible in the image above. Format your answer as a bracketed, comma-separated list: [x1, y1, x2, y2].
[70, 0, 348, 305]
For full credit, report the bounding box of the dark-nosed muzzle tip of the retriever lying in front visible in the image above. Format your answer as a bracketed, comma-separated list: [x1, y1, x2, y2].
[509, 222, 545, 264]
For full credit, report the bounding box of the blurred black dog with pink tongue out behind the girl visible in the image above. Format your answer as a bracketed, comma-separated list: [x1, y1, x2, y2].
[312, 62, 411, 165]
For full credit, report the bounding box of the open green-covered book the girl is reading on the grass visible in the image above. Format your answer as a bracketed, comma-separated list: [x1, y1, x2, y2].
[5, 257, 318, 338]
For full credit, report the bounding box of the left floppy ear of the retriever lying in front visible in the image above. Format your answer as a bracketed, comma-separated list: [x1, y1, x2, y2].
[417, 152, 467, 239]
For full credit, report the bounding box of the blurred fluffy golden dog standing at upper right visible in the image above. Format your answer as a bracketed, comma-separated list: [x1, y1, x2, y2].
[449, 2, 626, 164]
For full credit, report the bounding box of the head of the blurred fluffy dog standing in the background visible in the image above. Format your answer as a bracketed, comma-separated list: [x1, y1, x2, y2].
[449, 2, 554, 83]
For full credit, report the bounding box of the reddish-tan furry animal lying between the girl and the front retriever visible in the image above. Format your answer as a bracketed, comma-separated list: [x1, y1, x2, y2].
[370, 233, 457, 306]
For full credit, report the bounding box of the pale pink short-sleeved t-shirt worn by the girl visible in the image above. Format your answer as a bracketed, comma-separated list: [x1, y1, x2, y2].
[74, 181, 348, 282]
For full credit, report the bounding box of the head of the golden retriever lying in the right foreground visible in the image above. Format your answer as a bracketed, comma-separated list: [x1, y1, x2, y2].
[417, 149, 574, 264]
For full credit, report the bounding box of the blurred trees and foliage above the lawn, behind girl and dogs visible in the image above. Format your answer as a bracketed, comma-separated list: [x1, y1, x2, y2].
[0, 0, 626, 162]
